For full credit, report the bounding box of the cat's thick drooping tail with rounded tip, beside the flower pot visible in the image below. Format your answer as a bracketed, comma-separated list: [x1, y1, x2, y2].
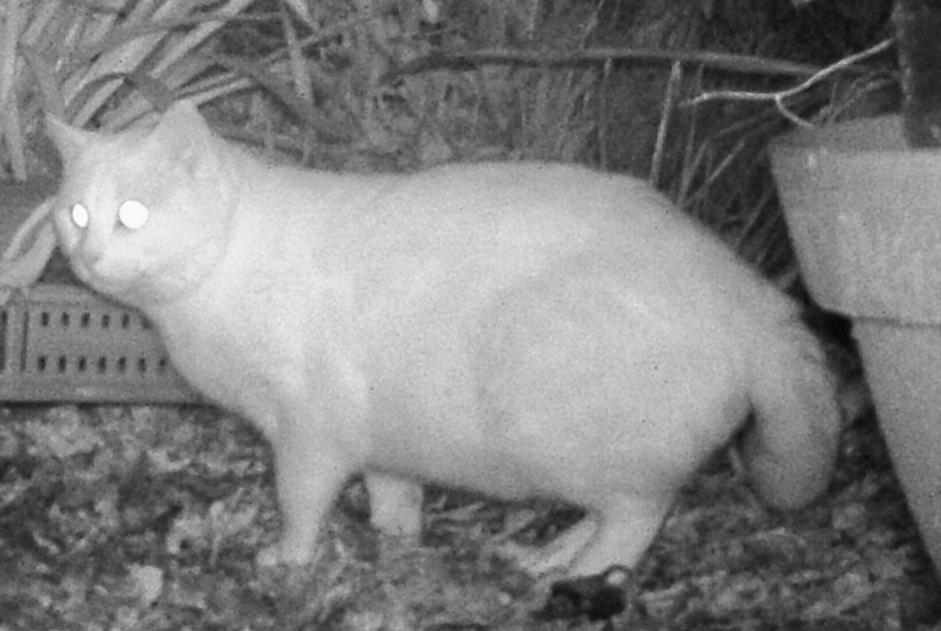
[744, 315, 841, 509]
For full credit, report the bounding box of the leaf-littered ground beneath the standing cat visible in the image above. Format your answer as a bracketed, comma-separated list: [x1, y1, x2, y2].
[0, 406, 941, 631]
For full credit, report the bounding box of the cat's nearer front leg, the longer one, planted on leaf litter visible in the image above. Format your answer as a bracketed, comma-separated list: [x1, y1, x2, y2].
[255, 430, 351, 567]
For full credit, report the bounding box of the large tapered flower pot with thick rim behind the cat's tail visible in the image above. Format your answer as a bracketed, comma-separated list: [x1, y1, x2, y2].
[771, 116, 941, 573]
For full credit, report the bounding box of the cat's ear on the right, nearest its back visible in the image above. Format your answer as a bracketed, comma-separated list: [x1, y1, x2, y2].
[148, 100, 215, 176]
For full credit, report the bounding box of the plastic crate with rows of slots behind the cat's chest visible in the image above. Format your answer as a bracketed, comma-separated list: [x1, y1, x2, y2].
[0, 284, 200, 403]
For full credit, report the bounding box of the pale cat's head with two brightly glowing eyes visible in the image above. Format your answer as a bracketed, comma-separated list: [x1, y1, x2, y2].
[47, 101, 237, 306]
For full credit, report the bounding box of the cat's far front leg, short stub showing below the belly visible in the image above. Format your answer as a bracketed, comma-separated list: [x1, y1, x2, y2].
[366, 473, 422, 539]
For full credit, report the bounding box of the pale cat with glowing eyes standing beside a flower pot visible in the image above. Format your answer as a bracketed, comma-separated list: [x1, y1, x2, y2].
[47, 101, 841, 576]
